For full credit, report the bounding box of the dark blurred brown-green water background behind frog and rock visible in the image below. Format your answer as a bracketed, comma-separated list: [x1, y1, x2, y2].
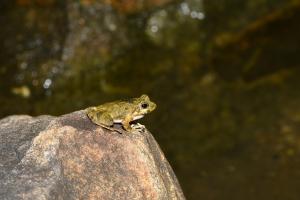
[0, 0, 300, 200]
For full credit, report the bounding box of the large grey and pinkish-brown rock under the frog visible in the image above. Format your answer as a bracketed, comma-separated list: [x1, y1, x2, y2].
[0, 111, 185, 200]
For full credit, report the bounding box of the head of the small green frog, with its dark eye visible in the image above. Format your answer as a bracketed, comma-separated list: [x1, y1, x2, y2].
[134, 94, 156, 118]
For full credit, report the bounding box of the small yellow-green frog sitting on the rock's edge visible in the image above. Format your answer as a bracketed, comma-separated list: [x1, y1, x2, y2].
[86, 94, 156, 131]
